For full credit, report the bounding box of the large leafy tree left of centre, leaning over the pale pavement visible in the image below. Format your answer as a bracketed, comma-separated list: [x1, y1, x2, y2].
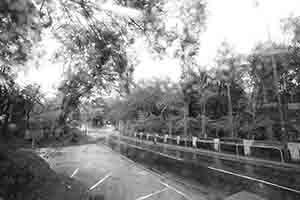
[49, 1, 137, 128]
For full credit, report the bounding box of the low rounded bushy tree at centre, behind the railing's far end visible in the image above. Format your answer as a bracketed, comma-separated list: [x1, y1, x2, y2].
[105, 80, 182, 132]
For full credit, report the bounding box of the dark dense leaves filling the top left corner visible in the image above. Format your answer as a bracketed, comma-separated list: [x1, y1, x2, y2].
[0, 0, 51, 67]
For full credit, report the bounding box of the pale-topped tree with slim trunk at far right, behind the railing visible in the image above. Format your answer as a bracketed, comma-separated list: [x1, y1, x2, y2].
[250, 42, 293, 139]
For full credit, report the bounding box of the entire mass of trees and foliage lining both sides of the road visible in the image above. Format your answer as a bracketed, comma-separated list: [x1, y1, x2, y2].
[0, 0, 300, 140]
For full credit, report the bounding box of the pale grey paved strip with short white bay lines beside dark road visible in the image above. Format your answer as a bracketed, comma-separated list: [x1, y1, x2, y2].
[39, 128, 207, 200]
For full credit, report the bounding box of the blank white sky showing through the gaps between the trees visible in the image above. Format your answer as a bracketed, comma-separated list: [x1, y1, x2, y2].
[18, 0, 300, 96]
